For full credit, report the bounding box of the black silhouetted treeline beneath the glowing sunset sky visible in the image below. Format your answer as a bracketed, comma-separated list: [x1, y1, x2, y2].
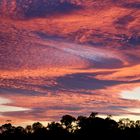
[0, 113, 140, 140]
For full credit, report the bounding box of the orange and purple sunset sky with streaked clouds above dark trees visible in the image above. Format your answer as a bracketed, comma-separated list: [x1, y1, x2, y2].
[0, 0, 140, 125]
